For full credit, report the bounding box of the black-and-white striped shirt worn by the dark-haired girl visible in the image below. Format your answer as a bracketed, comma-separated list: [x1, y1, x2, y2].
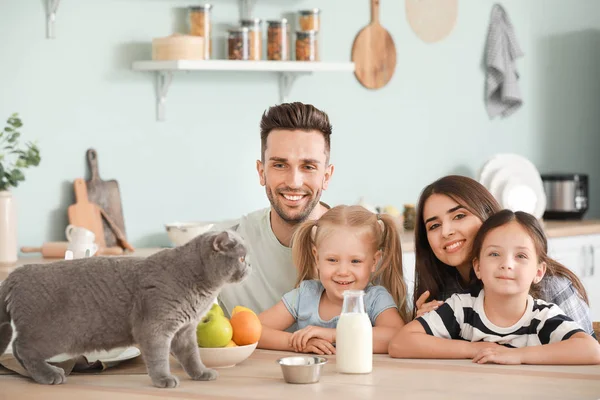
[417, 289, 584, 348]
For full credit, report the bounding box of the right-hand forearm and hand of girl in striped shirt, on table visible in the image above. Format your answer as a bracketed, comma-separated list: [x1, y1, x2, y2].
[473, 332, 600, 364]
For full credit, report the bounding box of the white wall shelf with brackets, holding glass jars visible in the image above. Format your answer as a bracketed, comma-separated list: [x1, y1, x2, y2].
[132, 60, 355, 121]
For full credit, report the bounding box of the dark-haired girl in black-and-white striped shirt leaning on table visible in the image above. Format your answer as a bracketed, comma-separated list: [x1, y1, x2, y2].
[389, 210, 600, 364]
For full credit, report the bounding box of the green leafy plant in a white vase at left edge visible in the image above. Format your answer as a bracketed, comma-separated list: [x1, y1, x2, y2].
[0, 113, 40, 263]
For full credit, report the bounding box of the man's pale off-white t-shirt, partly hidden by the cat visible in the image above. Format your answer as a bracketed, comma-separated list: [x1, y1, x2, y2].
[218, 207, 297, 315]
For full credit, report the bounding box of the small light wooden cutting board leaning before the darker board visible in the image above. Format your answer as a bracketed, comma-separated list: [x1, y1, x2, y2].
[67, 178, 106, 247]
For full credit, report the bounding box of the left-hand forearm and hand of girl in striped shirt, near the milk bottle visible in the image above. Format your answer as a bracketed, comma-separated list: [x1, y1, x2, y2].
[388, 320, 501, 358]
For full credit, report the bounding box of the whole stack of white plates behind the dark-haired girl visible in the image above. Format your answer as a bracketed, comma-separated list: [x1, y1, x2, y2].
[479, 154, 546, 219]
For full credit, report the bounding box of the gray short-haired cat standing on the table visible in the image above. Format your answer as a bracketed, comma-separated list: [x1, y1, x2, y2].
[0, 231, 250, 387]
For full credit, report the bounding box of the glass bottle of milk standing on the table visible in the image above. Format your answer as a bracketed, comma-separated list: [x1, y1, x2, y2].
[335, 290, 373, 374]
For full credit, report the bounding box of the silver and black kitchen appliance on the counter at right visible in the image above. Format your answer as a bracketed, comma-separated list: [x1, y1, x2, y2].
[542, 173, 589, 220]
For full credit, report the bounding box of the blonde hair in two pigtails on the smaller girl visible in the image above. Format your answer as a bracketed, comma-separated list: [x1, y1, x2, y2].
[292, 205, 409, 322]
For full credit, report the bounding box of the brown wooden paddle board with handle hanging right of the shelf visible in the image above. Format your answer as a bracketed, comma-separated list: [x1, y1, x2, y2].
[352, 0, 396, 89]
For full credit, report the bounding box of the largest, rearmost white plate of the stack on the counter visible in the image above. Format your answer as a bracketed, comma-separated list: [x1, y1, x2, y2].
[479, 153, 546, 218]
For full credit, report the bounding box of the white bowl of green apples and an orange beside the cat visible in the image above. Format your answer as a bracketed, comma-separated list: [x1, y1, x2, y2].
[196, 304, 262, 368]
